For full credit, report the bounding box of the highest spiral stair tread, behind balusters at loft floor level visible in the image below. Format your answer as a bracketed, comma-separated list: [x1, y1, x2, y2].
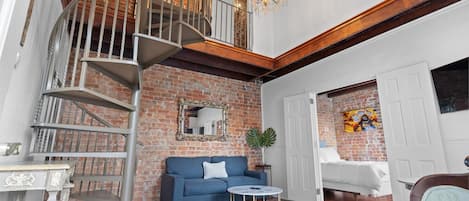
[162, 21, 205, 45]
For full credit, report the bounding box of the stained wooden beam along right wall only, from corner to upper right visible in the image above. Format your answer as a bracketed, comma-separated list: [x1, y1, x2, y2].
[259, 0, 460, 81]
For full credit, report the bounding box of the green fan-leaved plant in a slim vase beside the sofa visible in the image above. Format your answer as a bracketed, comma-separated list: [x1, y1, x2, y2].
[246, 128, 277, 164]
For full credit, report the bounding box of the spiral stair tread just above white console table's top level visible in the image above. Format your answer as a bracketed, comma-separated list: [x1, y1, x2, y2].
[30, 152, 127, 158]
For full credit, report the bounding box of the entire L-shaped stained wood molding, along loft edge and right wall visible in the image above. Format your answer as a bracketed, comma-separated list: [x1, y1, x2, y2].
[185, 0, 459, 81]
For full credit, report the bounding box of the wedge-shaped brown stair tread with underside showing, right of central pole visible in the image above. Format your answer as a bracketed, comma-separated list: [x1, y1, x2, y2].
[134, 33, 182, 68]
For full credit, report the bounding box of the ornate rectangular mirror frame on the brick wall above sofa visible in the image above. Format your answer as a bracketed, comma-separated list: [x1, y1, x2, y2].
[176, 99, 228, 142]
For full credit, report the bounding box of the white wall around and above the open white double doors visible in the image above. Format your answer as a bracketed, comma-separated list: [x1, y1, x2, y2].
[262, 1, 469, 199]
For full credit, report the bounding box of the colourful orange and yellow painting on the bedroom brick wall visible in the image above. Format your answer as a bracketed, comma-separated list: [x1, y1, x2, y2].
[344, 108, 379, 133]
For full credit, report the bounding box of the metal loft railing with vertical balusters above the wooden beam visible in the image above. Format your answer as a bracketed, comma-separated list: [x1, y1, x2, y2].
[139, 0, 253, 50]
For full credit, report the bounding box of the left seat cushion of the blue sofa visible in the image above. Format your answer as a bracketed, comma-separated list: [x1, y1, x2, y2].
[184, 179, 227, 196]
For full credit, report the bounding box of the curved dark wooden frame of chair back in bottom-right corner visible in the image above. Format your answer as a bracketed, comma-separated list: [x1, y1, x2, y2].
[410, 173, 469, 201]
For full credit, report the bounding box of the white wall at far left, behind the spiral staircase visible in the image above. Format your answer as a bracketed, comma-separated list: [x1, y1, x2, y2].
[0, 0, 62, 162]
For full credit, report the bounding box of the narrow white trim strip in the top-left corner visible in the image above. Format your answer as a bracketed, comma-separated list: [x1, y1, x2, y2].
[0, 1, 16, 59]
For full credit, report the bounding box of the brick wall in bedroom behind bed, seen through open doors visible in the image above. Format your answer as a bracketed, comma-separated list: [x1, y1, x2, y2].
[332, 85, 387, 161]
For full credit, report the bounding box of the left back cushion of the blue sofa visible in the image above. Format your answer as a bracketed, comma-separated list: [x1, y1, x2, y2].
[166, 157, 210, 179]
